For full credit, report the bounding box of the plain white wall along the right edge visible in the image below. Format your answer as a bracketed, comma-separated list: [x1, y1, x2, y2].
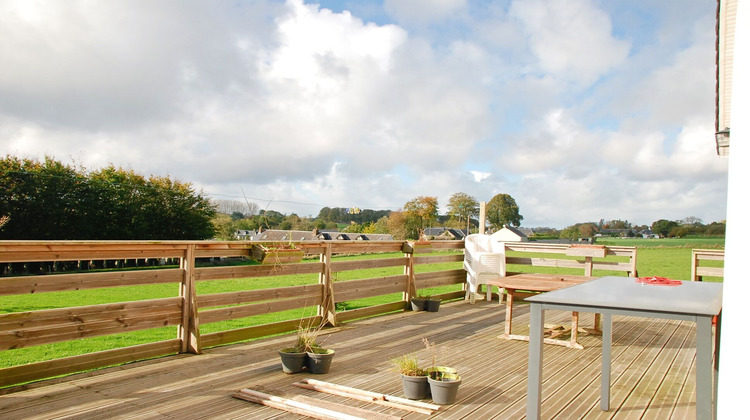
[718, 1, 750, 419]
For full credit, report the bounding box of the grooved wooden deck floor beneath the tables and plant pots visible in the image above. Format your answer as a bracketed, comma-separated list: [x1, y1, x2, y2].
[0, 301, 695, 420]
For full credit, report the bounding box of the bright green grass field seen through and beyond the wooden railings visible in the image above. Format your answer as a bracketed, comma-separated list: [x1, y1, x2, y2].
[0, 238, 724, 367]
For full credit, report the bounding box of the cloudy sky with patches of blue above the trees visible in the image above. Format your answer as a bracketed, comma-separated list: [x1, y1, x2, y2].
[0, 0, 728, 228]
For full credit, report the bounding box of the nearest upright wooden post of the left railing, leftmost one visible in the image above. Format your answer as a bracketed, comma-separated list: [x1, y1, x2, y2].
[177, 244, 201, 354]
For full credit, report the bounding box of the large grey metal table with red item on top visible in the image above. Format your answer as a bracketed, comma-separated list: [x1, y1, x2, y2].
[526, 277, 723, 419]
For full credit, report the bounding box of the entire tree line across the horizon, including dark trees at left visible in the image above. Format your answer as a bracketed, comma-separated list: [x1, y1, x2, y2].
[0, 155, 726, 240]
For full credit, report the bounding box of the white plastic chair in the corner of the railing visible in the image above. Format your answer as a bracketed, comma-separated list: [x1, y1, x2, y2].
[464, 234, 505, 301]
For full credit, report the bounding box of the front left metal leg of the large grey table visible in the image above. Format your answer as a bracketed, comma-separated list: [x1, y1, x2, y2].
[526, 303, 544, 419]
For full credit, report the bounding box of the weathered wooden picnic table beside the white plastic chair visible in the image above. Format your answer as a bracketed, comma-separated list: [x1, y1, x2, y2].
[487, 273, 601, 349]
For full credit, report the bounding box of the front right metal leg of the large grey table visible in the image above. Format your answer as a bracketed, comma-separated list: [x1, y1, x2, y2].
[695, 316, 714, 419]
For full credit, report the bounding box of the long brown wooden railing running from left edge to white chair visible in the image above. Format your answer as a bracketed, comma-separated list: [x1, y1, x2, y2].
[0, 241, 465, 386]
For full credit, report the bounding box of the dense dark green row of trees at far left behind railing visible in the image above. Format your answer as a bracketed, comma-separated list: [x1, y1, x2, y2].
[0, 156, 216, 240]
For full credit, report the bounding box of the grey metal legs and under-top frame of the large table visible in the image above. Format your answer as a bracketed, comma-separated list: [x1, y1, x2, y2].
[526, 279, 721, 419]
